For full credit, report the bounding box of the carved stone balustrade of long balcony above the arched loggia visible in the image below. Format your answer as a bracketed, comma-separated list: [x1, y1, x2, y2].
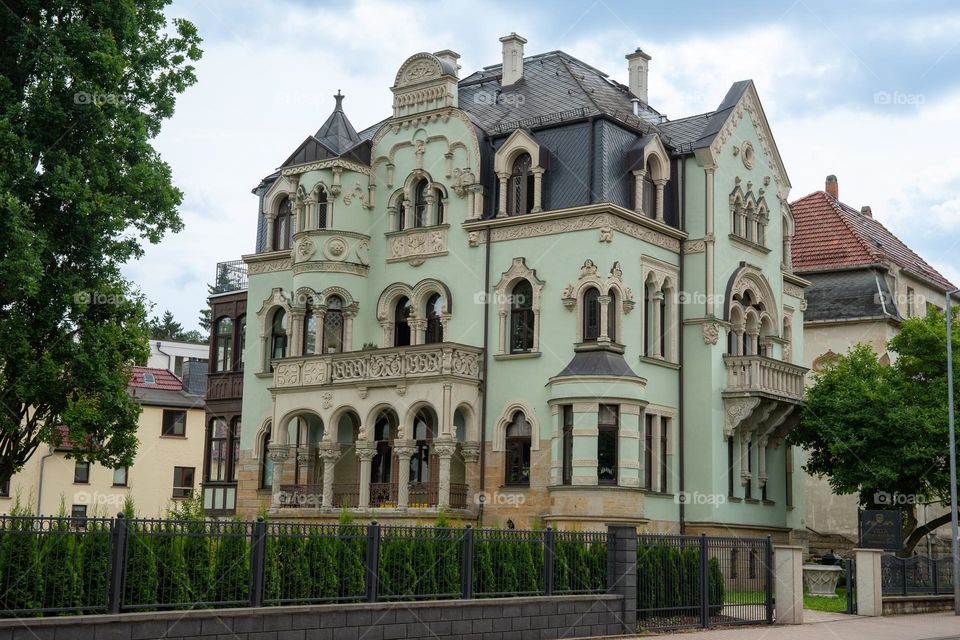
[274, 342, 483, 389]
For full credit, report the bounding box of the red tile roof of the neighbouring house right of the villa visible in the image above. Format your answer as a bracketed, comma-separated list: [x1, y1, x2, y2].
[790, 191, 954, 289]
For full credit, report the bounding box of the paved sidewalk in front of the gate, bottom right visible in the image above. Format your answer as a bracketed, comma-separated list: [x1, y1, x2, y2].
[634, 612, 960, 640]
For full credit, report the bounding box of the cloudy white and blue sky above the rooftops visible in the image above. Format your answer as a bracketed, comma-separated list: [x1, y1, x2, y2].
[125, 0, 960, 328]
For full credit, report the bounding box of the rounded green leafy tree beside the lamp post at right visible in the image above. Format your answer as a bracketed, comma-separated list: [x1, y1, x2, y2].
[789, 310, 960, 555]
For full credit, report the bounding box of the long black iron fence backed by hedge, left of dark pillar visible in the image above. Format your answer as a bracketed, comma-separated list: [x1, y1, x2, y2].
[0, 516, 608, 615]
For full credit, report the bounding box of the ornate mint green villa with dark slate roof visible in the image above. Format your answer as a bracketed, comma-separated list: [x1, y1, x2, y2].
[227, 34, 806, 541]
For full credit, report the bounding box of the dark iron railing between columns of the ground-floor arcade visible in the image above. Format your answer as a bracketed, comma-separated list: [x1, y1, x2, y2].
[280, 482, 467, 509]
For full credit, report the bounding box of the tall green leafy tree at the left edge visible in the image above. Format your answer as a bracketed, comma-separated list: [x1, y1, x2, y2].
[0, 0, 201, 480]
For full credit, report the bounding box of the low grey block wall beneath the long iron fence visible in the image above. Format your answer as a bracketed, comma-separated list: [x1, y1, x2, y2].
[0, 595, 623, 640]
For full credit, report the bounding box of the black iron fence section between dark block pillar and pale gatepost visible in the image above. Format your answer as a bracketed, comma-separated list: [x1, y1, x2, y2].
[637, 535, 773, 629]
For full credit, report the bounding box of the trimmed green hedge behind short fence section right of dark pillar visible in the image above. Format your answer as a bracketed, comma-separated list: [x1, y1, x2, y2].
[637, 546, 724, 618]
